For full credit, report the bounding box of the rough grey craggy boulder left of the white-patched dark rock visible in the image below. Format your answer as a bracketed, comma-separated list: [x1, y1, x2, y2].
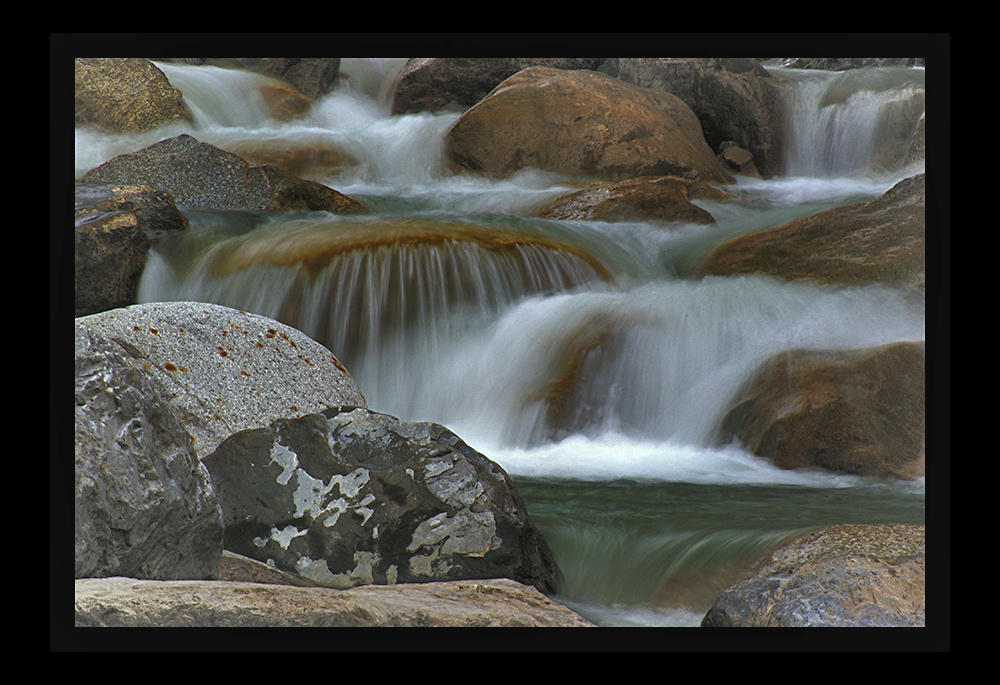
[74, 319, 222, 580]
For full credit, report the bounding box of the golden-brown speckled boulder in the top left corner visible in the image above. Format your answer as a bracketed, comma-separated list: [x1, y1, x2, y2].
[74, 57, 193, 134]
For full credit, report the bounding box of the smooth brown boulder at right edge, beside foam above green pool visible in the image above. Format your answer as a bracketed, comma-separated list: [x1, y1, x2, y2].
[720, 342, 926, 478]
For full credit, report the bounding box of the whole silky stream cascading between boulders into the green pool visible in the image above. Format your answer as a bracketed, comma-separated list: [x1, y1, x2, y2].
[76, 59, 924, 626]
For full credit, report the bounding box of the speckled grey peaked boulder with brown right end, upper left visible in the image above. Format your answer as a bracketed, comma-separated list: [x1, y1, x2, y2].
[82, 134, 367, 214]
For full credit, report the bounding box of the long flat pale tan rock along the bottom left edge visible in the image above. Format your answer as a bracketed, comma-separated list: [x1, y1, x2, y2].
[75, 578, 593, 628]
